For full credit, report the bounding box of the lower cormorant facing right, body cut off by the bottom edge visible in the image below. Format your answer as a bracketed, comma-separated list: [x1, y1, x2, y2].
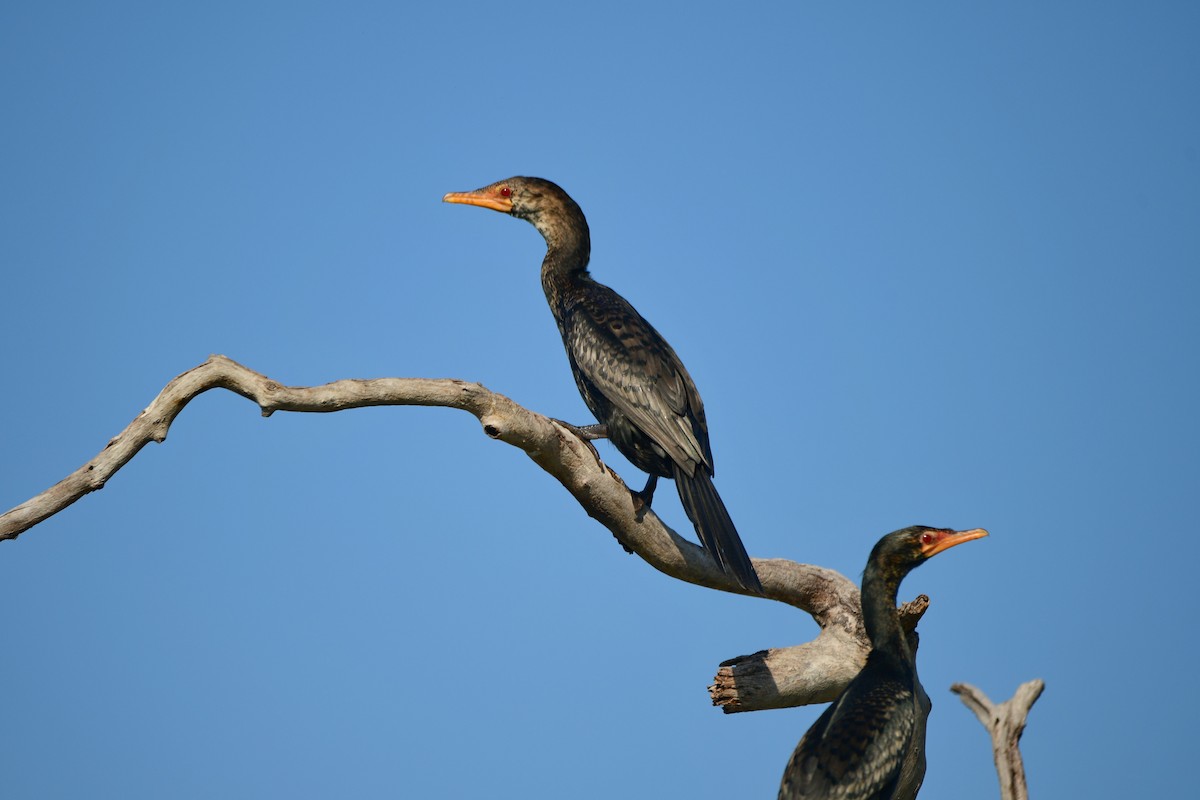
[779, 525, 988, 800]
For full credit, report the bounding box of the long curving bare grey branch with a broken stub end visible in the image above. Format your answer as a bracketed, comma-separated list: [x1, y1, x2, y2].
[0, 355, 924, 712]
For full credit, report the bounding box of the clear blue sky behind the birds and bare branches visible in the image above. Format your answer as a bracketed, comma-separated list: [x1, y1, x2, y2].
[0, 2, 1200, 800]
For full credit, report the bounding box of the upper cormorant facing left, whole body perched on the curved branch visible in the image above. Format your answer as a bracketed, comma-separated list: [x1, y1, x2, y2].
[443, 178, 762, 593]
